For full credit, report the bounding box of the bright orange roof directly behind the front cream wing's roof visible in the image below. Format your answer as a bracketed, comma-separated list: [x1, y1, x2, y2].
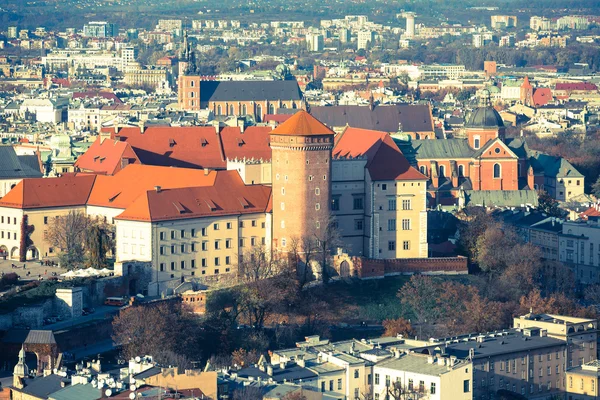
[88, 164, 223, 209]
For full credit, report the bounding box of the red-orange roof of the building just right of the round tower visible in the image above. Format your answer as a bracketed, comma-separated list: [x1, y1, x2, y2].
[333, 128, 428, 181]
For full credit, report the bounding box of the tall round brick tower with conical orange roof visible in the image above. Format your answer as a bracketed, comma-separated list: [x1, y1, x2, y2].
[270, 110, 334, 252]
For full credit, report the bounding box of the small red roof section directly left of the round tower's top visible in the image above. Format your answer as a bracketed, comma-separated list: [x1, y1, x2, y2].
[220, 126, 271, 160]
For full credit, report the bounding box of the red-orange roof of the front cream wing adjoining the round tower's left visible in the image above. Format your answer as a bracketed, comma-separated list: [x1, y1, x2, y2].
[117, 174, 271, 221]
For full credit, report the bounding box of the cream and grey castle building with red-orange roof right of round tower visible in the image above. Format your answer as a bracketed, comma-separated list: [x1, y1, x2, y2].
[331, 128, 428, 259]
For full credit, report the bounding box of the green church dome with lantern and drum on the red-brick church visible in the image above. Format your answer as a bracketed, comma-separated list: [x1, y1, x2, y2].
[465, 89, 505, 150]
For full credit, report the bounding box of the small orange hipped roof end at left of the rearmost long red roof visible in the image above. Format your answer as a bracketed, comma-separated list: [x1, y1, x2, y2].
[75, 137, 140, 175]
